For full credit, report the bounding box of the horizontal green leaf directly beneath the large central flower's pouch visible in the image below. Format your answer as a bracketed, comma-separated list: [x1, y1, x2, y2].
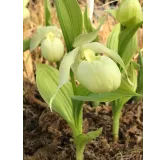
[71, 79, 140, 102]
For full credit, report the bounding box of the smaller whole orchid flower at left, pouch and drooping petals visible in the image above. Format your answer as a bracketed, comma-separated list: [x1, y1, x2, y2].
[30, 26, 64, 62]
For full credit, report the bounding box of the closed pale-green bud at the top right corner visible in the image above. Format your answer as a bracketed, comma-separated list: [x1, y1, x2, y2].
[116, 0, 143, 27]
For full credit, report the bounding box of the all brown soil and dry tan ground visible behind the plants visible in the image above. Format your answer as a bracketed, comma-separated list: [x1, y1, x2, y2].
[23, 0, 143, 160]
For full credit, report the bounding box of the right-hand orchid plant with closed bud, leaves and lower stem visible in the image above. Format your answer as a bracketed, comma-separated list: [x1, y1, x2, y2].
[107, 0, 144, 142]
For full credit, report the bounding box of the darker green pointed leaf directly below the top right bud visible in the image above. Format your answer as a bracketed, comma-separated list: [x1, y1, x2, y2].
[118, 21, 143, 56]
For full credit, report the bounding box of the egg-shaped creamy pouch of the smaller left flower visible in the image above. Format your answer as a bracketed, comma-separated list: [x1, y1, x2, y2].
[41, 32, 64, 62]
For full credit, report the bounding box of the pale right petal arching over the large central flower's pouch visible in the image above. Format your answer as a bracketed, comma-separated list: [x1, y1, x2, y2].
[82, 42, 127, 75]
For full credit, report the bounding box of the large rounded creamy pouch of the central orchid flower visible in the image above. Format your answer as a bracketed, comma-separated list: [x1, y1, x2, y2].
[76, 49, 121, 93]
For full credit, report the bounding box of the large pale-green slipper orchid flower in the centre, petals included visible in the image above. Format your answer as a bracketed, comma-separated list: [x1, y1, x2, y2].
[49, 19, 127, 108]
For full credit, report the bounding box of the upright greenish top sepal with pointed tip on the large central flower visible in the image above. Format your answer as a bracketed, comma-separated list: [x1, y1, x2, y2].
[73, 17, 105, 47]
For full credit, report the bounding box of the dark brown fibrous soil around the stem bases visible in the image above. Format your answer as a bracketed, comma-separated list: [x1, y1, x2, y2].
[23, 81, 143, 160]
